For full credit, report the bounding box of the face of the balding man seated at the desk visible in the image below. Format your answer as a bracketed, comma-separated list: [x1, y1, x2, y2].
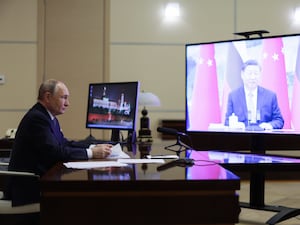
[48, 83, 70, 116]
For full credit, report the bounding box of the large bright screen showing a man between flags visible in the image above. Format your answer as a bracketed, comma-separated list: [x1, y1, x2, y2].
[185, 34, 300, 133]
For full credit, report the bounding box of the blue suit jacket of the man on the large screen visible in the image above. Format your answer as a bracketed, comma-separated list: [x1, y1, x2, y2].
[225, 87, 284, 129]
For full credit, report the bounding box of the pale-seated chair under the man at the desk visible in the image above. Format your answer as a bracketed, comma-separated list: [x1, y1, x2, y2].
[0, 162, 40, 225]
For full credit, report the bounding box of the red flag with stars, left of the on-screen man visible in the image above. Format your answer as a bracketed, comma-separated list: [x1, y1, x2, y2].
[189, 44, 221, 130]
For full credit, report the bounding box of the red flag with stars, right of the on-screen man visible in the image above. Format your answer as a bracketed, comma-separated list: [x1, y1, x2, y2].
[261, 38, 291, 129]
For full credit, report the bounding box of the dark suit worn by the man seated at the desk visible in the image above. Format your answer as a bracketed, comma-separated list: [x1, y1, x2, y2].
[5, 103, 88, 205]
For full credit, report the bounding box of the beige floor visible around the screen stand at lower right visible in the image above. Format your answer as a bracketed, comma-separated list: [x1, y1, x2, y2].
[237, 179, 300, 225]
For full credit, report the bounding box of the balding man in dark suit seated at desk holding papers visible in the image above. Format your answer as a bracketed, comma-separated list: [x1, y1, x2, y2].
[5, 79, 112, 206]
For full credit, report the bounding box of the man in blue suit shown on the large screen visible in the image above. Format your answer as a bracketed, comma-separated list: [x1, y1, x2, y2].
[225, 60, 284, 130]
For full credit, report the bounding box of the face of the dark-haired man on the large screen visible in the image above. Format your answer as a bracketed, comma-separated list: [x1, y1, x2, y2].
[242, 65, 261, 90]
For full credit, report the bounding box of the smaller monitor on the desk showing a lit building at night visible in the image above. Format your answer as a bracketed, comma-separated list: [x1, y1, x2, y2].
[86, 81, 139, 142]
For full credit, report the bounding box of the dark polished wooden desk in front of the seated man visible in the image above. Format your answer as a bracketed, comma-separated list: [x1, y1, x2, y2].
[41, 144, 240, 225]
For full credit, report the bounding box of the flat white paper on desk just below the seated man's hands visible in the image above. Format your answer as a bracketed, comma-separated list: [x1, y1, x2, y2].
[64, 161, 128, 169]
